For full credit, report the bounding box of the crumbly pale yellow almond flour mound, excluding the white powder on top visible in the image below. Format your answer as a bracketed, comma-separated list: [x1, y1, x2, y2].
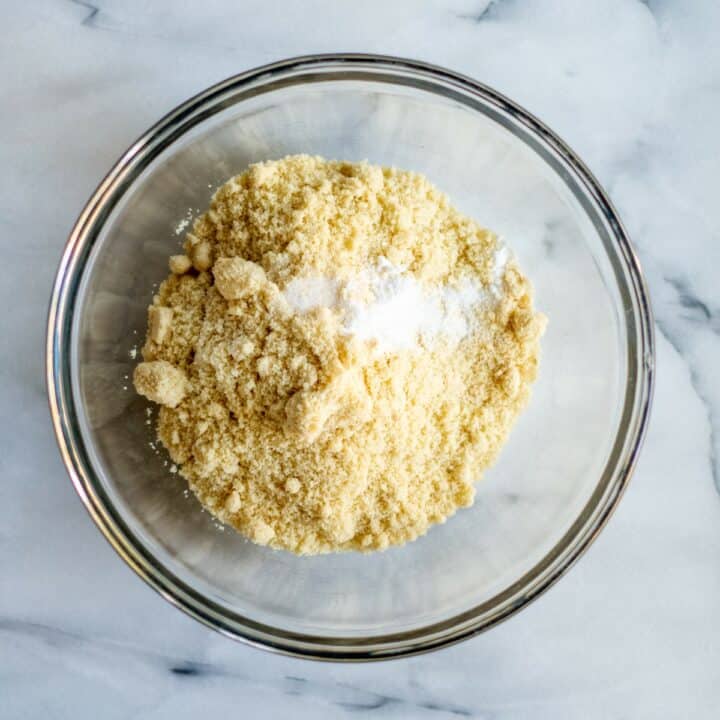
[134, 156, 544, 554]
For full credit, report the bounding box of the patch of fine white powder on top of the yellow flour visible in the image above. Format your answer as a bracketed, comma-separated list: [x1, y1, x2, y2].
[285, 246, 512, 352]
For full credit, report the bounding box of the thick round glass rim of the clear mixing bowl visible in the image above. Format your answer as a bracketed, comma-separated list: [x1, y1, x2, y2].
[46, 53, 655, 661]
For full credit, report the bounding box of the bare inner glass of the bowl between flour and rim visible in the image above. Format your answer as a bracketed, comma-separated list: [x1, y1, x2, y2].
[70, 66, 628, 639]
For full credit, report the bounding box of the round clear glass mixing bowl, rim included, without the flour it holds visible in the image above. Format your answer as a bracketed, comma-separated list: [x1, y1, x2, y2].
[47, 55, 654, 660]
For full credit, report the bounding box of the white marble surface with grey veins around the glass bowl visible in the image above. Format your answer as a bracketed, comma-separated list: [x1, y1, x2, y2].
[0, 0, 720, 720]
